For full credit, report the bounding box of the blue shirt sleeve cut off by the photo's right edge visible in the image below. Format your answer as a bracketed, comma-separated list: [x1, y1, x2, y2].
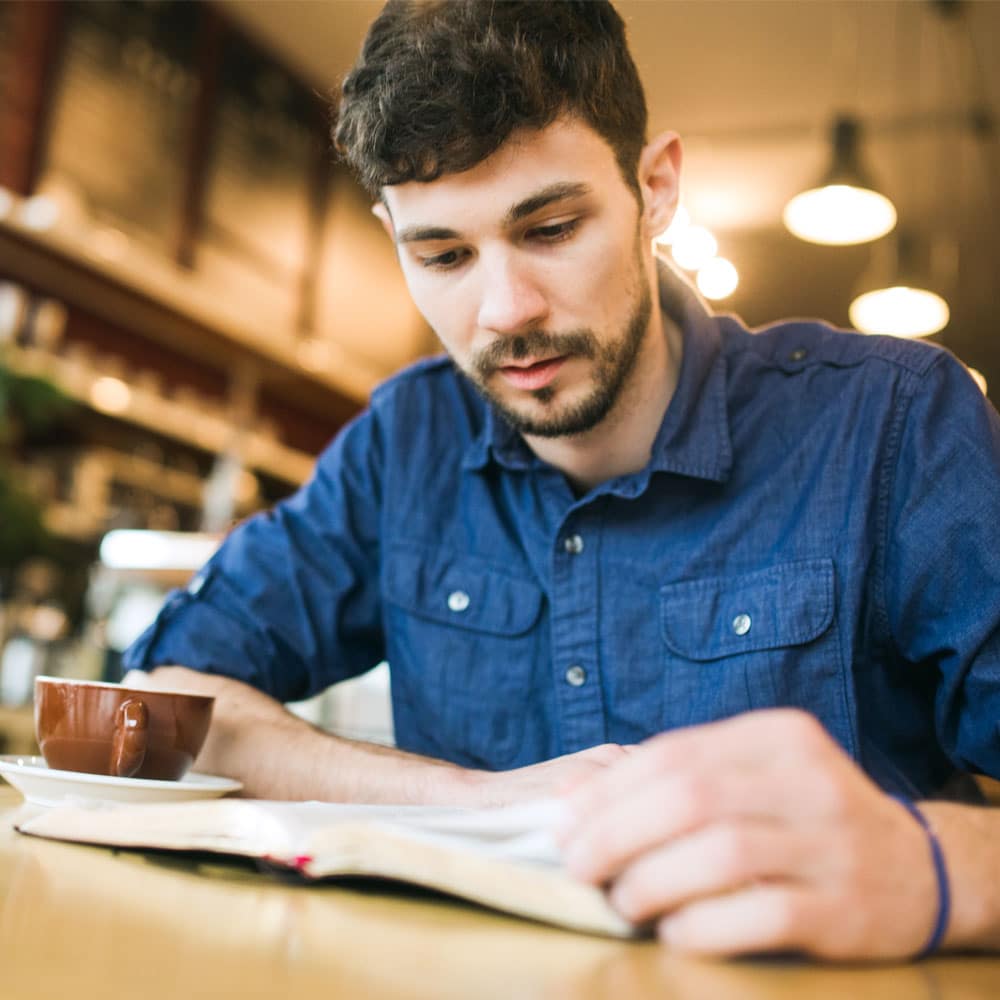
[882, 354, 1000, 776]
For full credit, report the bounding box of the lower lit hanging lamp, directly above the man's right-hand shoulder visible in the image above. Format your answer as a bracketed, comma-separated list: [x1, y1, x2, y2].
[848, 233, 951, 337]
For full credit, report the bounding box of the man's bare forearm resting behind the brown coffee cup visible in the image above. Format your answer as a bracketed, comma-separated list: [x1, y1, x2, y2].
[127, 666, 482, 805]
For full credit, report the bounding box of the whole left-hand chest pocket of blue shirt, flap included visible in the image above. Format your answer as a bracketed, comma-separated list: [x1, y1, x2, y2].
[383, 545, 545, 769]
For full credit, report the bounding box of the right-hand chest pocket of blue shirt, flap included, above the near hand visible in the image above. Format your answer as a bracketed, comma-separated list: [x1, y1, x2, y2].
[660, 559, 853, 746]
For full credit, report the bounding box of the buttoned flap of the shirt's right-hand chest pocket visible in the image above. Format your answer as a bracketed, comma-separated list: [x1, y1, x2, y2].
[660, 559, 834, 660]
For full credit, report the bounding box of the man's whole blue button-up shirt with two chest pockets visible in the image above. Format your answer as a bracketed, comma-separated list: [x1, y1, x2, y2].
[126, 275, 1000, 794]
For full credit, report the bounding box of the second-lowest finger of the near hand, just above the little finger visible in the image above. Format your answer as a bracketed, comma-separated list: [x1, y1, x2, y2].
[610, 822, 825, 923]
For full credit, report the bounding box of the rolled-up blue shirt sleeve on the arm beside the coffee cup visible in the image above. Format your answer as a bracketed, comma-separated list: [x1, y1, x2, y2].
[124, 410, 384, 701]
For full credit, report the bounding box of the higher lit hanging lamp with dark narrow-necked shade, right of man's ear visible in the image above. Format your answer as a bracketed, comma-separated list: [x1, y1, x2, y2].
[782, 115, 896, 246]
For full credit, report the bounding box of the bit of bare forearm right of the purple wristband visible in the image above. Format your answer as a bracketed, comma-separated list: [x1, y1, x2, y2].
[920, 802, 1000, 951]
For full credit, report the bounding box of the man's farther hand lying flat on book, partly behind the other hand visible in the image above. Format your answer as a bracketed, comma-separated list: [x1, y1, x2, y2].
[472, 743, 635, 806]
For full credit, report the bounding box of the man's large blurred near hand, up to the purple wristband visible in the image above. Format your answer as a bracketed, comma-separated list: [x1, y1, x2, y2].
[560, 709, 938, 959]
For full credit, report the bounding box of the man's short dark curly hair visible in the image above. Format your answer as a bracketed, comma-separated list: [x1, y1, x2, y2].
[334, 0, 647, 196]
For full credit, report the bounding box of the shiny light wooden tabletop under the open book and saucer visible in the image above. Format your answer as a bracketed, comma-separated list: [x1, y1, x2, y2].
[0, 782, 1000, 1000]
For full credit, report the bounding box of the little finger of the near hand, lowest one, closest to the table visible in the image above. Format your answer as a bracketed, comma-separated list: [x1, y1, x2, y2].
[657, 883, 815, 955]
